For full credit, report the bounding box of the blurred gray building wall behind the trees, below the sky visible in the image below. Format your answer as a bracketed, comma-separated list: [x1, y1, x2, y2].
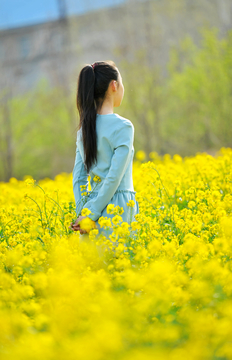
[0, 0, 232, 96]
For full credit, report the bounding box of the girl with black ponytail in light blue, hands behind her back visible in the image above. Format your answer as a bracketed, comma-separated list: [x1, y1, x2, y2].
[71, 61, 139, 238]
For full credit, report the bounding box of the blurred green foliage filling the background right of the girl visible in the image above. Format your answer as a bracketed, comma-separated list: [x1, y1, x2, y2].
[120, 29, 232, 156]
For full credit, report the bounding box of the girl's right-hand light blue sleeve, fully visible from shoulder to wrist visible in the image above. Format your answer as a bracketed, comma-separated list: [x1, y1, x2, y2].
[83, 122, 134, 221]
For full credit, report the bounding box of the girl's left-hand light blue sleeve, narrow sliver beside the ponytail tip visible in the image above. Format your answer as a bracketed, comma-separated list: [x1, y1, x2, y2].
[73, 146, 88, 214]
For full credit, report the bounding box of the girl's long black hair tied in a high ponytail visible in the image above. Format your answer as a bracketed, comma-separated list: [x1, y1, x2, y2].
[77, 61, 119, 173]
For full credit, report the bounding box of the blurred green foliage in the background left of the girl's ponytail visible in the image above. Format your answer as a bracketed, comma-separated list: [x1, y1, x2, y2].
[0, 79, 77, 181]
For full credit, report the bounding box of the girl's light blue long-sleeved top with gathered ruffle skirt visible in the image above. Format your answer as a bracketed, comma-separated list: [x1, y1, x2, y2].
[73, 114, 139, 222]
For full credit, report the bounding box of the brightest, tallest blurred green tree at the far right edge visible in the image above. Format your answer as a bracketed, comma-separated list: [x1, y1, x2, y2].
[163, 29, 232, 155]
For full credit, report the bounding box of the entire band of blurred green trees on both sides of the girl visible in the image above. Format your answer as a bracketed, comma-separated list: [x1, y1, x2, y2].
[0, 29, 232, 181]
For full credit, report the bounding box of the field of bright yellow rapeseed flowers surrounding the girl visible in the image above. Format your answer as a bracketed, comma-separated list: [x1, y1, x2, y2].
[0, 148, 232, 360]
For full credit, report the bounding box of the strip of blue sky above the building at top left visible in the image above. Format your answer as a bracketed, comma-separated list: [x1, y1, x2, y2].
[0, 0, 125, 29]
